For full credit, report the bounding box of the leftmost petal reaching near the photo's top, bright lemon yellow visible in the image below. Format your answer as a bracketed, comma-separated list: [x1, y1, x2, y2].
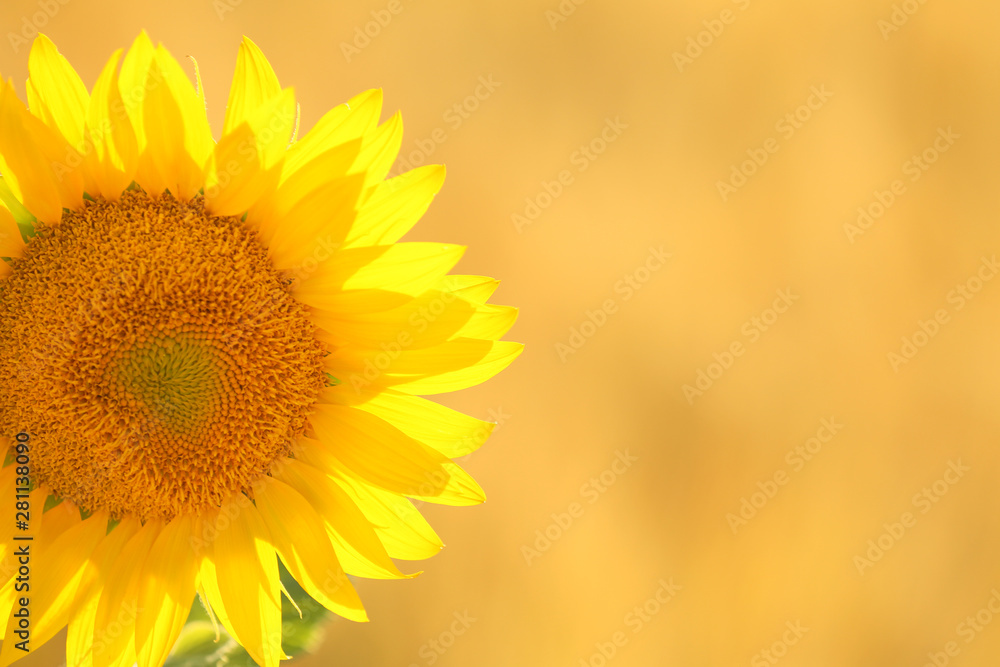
[28, 35, 90, 152]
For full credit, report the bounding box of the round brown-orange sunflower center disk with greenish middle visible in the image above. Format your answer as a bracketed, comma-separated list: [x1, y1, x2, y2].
[0, 192, 325, 519]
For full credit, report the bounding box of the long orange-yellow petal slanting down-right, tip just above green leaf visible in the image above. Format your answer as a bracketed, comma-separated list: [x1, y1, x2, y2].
[254, 478, 368, 621]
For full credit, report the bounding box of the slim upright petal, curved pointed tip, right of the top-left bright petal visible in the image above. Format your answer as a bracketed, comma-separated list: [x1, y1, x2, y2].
[86, 49, 139, 200]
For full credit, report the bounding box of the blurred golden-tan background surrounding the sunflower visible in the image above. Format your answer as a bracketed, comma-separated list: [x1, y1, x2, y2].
[0, 0, 1000, 667]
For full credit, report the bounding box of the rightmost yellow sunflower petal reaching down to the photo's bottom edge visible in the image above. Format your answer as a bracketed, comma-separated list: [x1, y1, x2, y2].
[211, 503, 283, 667]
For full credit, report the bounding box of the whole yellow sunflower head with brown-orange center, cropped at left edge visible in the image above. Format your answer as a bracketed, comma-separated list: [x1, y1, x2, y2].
[0, 33, 521, 667]
